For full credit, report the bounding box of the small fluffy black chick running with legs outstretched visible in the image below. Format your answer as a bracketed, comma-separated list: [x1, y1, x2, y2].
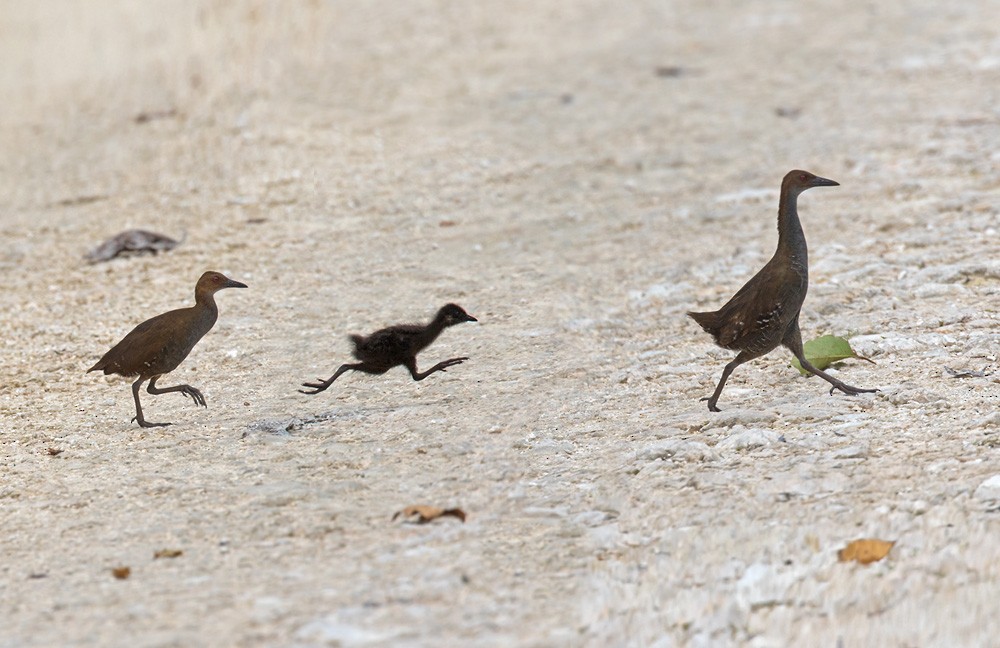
[299, 304, 479, 394]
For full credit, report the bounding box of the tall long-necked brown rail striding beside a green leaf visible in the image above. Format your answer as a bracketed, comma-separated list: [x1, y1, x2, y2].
[688, 171, 877, 412]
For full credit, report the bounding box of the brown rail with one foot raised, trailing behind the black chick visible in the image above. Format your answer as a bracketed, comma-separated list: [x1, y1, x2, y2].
[87, 272, 247, 427]
